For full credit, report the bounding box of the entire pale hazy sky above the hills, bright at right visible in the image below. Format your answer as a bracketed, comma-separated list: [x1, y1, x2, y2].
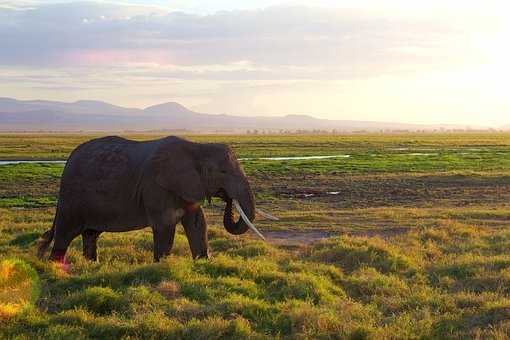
[0, 0, 510, 126]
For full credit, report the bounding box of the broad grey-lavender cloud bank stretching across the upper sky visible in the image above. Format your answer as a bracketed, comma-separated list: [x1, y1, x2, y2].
[0, 2, 470, 79]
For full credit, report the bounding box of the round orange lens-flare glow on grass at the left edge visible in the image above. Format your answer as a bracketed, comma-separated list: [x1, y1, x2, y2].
[0, 259, 40, 319]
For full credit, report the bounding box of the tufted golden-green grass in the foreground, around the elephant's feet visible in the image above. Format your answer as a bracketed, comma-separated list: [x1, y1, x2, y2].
[4, 210, 510, 338]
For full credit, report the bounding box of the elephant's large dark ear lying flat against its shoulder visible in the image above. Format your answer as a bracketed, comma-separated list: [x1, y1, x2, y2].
[150, 142, 205, 202]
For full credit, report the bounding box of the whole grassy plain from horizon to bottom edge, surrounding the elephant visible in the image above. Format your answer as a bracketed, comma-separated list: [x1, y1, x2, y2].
[0, 133, 510, 339]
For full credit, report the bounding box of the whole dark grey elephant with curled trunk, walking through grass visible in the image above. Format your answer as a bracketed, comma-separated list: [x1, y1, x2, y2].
[38, 136, 263, 262]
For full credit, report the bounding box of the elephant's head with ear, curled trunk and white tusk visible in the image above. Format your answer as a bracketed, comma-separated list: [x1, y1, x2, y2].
[152, 138, 263, 238]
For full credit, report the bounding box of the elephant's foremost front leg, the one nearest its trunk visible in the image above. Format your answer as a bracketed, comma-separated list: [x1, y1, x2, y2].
[181, 207, 209, 259]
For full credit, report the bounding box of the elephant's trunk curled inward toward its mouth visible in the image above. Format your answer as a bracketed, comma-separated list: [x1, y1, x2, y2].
[223, 181, 255, 235]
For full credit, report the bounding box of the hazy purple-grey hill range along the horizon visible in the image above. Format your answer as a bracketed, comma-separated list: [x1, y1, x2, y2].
[0, 98, 486, 132]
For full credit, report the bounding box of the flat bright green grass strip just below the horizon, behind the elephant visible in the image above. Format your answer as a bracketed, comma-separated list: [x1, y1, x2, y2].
[0, 133, 510, 179]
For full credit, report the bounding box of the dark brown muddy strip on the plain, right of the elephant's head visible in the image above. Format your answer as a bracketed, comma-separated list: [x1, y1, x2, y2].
[255, 175, 510, 208]
